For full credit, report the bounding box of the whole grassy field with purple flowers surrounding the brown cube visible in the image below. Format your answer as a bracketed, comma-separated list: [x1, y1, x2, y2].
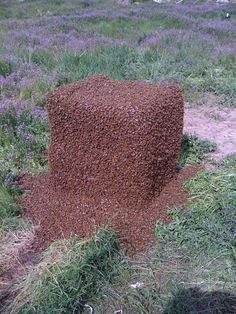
[0, 0, 236, 314]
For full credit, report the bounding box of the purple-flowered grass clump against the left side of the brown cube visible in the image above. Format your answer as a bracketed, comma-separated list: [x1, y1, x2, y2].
[0, 106, 49, 186]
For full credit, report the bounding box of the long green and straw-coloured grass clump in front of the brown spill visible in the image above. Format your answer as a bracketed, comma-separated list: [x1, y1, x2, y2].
[8, 229, 121, 314]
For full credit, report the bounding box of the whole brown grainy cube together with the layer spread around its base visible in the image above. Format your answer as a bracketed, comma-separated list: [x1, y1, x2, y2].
[20, 75, 189, 252]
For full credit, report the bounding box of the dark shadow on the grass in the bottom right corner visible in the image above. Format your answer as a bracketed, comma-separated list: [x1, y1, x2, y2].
[164, 288, 236, 314]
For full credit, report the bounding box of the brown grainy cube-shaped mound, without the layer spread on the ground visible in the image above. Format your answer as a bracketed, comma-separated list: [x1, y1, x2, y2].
[47, 75, 184, 206]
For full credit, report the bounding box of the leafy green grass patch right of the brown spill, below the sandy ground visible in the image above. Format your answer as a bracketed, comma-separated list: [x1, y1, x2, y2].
[157, 156, 236, 258]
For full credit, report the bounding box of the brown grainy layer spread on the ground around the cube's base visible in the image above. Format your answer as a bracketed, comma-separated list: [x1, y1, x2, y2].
[19, 166, 200, 255]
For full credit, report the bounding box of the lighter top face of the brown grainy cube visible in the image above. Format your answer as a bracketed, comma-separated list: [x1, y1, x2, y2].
[48, 74, 181, 123]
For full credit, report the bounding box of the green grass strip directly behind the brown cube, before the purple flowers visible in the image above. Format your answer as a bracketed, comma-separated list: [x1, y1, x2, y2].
[29, 41, 236, 106]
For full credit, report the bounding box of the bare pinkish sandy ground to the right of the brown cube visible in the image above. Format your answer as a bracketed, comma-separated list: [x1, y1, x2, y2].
[184, 106, 236, 160]
